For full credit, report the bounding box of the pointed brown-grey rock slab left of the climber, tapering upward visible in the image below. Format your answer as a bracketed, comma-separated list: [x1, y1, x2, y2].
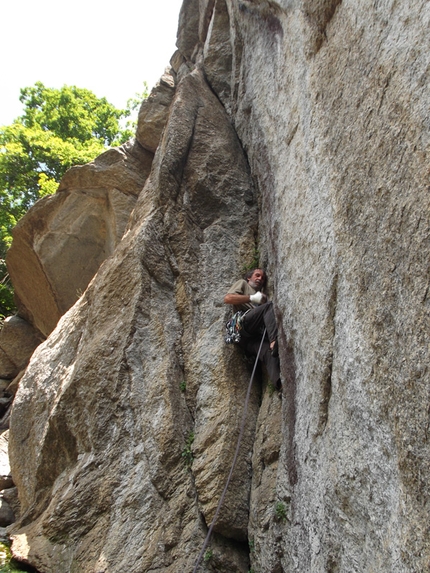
[10, 66, 258, 573]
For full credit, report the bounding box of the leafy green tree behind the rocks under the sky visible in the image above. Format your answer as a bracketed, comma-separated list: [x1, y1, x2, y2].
[0, 82, 147, 316]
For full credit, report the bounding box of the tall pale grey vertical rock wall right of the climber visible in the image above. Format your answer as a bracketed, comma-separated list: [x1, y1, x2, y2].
[203, 0, 430, 573]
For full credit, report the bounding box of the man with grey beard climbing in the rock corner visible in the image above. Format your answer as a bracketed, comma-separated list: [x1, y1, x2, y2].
[224, 269, 282, 390]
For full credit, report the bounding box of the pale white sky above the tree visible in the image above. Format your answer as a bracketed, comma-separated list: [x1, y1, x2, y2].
[0, 0, 182, 125]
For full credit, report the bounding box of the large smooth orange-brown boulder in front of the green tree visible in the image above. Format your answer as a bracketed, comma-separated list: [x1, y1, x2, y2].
[6, 138, 152, 336]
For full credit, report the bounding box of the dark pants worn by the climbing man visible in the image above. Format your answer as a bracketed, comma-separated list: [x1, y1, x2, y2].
[239, 302, 281, 386]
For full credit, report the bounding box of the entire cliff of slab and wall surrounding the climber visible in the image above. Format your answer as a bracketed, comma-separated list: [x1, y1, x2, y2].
[5, 0, 430, 573]
